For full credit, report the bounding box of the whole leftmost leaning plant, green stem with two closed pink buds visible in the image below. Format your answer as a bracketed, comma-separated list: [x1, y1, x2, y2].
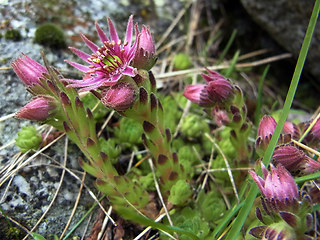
[12, 50, 149, 214]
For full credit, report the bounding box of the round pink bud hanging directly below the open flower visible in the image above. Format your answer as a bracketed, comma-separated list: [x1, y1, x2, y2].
[101, 83, 136, 111]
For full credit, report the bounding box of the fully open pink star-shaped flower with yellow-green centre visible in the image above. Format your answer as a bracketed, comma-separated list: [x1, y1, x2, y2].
[65, 16, 137, 91]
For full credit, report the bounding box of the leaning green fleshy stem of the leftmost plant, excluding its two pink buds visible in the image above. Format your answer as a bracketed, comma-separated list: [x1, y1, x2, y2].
[46, 64, 149, 212]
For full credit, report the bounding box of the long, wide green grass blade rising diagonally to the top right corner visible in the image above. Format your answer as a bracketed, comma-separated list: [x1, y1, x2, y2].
[226, 0, 320, 240]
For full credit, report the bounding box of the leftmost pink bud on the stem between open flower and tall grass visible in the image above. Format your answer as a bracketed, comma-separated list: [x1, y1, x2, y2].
[183, 84, 214, 107]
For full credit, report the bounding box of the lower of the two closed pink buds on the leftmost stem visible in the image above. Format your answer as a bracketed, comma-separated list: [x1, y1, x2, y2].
[16, 97, 55, 121]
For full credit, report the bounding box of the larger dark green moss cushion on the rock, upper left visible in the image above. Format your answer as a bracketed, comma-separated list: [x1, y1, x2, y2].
[34, 23, 67, 49]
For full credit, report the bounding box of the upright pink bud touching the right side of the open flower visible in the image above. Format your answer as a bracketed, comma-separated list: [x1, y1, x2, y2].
[133, 25, 157, 70]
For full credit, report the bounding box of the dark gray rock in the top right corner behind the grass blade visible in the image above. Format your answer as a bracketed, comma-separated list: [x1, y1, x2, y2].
[241, 0, 320, 81]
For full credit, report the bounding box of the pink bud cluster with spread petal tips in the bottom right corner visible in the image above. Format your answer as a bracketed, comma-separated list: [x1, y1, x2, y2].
[249, 163, 312, 240]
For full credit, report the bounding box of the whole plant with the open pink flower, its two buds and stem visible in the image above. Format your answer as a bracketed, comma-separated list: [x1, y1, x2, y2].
[64, 16, 190, 202]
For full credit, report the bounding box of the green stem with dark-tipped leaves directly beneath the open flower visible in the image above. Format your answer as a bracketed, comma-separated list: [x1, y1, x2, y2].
[122, 70, 186, 197]
